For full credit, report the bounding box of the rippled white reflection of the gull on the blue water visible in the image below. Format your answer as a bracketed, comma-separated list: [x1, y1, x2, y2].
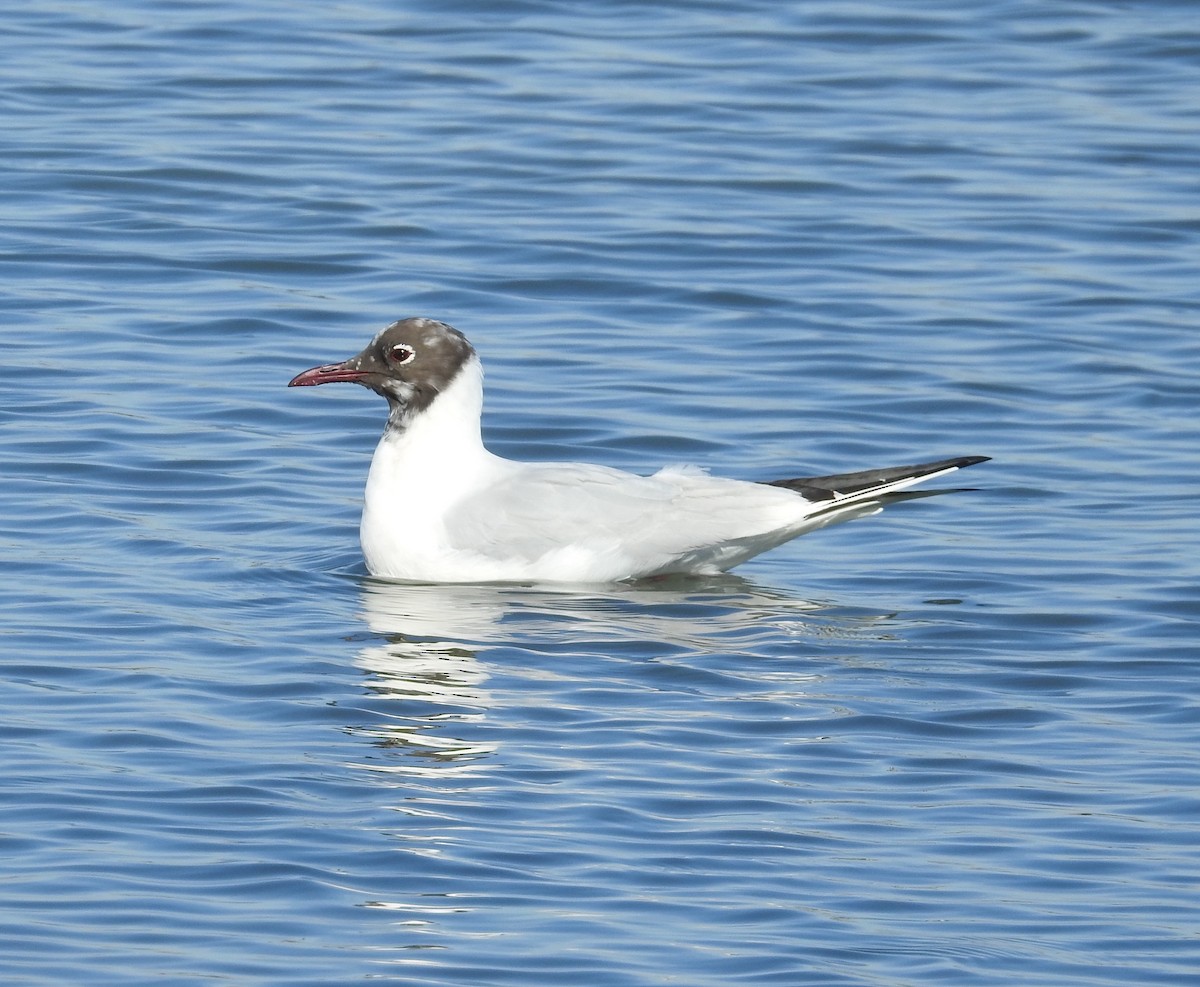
[343, 575, 890, 777]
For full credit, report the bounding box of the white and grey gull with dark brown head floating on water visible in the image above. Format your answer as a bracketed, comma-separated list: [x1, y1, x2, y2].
[288, 318, 988, 582]
